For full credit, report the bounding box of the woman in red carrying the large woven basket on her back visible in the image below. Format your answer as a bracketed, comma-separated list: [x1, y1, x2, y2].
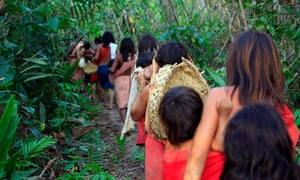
[131, 42, 189, 180]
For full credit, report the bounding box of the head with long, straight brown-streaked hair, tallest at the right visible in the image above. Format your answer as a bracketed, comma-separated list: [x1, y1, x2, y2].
[226, 31, 284, 105]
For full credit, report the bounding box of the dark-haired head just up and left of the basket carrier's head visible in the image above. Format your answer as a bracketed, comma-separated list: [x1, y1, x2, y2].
[138, 34, 159, 53]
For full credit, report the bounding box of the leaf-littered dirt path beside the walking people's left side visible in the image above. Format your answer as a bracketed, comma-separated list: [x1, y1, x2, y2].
[95, 102, 145, 180]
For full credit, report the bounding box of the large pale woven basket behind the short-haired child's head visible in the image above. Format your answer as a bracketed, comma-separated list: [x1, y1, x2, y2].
[146, 59, 210, 140]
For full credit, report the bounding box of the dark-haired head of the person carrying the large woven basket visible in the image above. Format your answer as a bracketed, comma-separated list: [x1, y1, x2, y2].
[155, 42, 189, 67]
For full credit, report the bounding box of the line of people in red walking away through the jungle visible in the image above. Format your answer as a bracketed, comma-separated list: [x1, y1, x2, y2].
[71, 30, 300, 180]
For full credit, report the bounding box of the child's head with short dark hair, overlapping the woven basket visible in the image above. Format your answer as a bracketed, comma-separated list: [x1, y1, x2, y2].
[158, 86, 203, 145]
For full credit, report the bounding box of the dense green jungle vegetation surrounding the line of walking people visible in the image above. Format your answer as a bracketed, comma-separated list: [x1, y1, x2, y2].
[0, 0, 300, 178]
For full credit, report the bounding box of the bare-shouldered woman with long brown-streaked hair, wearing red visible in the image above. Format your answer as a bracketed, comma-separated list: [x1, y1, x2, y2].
[184, 31, 299, 180]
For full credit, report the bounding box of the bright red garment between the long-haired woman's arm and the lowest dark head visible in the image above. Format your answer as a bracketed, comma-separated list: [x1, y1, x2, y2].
[201, 151, 225, 180]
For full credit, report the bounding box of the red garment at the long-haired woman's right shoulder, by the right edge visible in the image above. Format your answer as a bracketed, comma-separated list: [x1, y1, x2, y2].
[276, 105, 299, 147]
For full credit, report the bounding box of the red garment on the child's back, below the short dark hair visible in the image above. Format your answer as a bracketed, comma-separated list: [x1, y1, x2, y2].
[163, 150, 189, 180]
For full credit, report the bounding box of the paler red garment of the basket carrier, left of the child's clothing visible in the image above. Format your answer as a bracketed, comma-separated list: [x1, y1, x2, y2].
[145, 134, 165, 180]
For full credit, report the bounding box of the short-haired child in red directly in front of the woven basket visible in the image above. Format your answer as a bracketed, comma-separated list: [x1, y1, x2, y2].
[158, 86, 231, 180]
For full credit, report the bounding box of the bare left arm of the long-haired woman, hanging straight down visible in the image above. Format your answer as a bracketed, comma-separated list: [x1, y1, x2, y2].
[184, 88, 220, 180]
